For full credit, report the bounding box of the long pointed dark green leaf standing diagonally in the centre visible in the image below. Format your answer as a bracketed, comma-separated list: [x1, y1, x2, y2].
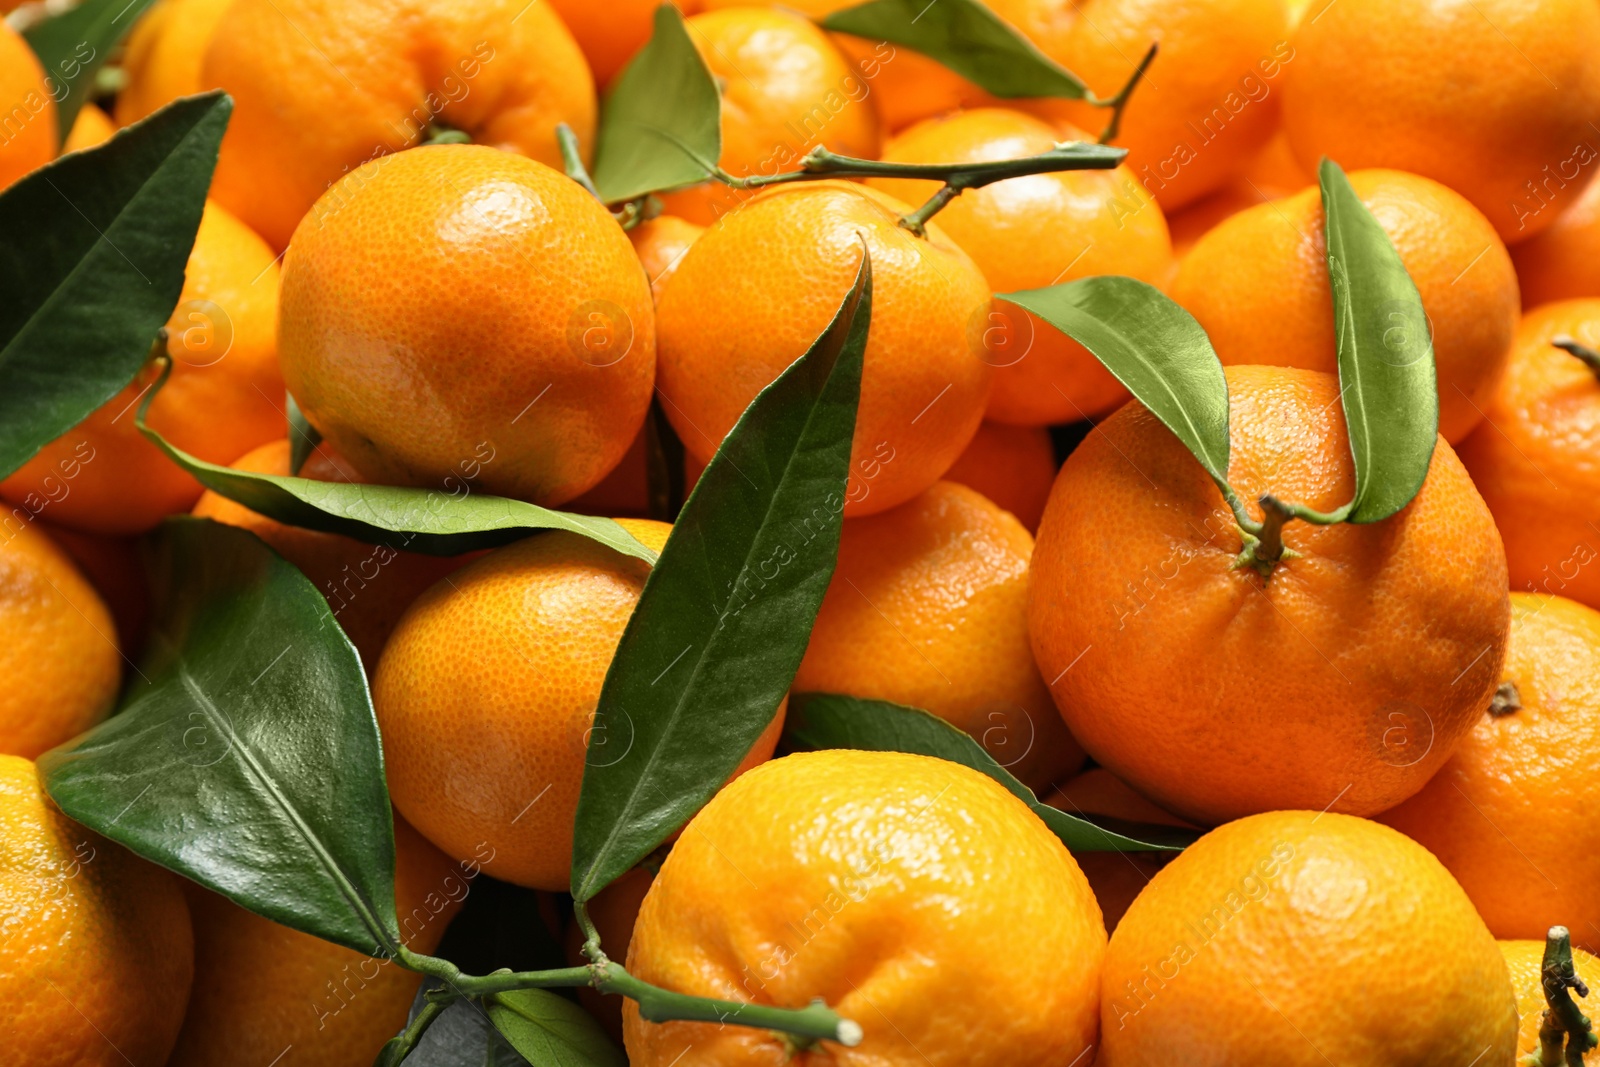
[571, 251, 872, 901]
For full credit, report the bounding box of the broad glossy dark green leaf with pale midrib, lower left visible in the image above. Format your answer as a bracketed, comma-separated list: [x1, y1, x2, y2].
[38, 517, 398, 955]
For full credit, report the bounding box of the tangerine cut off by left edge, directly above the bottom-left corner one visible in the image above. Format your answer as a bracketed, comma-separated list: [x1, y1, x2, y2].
[0, 512, 122, 760]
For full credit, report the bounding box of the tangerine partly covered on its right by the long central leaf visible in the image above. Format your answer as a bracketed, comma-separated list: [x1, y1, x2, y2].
[373, 518, 782, 891]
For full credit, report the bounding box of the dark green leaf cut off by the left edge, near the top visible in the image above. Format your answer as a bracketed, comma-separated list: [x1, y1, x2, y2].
[0, 93, 234, 477]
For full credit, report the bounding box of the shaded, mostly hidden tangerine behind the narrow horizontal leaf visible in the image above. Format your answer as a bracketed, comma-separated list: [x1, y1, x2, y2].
[194, 438, 461, 675]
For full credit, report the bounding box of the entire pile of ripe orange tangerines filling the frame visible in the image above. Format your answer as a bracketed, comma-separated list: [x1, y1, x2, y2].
[0, 0, 1600, 1067]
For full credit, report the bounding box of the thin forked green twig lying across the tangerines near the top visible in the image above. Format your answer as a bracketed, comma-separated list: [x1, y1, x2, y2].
[712, 141, 1128, 237]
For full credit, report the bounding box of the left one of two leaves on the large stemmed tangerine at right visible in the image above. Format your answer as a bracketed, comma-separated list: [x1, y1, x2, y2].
[997, 275, 1229, 485]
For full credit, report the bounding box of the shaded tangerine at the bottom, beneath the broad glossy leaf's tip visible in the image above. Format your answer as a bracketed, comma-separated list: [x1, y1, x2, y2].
[166, 819, 472, 1067]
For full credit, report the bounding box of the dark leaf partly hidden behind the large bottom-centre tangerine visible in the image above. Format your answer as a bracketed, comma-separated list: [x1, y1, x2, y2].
[786, 693, 1198, 853]
